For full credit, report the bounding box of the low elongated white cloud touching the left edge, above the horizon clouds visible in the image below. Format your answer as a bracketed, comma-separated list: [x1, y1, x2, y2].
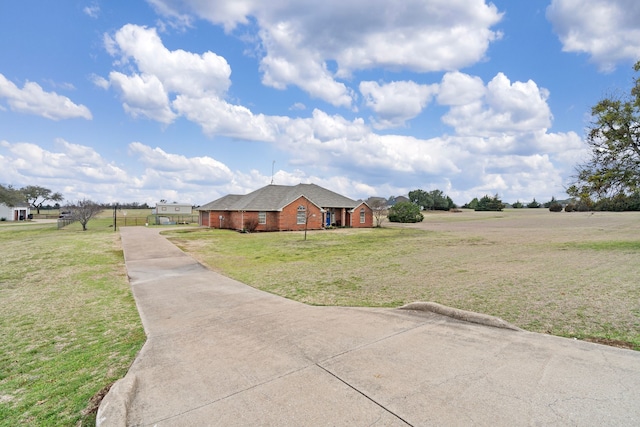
[0, 74, 92, 120]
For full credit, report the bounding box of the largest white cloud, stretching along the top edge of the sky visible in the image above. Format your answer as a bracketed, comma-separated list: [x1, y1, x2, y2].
[150, 0, 502, 107]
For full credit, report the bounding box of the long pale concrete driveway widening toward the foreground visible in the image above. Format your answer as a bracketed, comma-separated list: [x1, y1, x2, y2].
[97, 227, 640, 427]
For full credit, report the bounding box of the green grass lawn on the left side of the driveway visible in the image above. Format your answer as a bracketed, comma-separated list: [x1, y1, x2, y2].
[0, 219, 145, 426]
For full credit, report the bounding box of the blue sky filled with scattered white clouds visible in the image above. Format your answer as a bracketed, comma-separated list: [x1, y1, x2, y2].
[0, 0, 640, 206]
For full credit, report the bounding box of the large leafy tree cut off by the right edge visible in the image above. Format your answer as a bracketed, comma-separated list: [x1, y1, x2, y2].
[567, 61, 640, 200]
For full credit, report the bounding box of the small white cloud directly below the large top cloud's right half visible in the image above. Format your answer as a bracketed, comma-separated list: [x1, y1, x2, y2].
[360, 81, 438, 129]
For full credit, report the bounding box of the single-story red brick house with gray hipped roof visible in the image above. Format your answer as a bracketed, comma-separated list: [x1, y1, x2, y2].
[196, 184, 373, 231]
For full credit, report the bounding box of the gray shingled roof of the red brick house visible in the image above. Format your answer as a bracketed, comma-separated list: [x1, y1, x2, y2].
[197, 184, 361, 211]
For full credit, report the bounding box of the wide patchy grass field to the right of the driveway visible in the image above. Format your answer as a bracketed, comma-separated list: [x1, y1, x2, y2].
[169, 209, 640, 350]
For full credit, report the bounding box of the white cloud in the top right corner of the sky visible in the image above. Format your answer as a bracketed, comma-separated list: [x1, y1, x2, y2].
[547, 0, 640, 72]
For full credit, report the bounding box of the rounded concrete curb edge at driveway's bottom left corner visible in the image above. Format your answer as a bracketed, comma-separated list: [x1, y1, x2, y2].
[96, 375, 138, 427]
